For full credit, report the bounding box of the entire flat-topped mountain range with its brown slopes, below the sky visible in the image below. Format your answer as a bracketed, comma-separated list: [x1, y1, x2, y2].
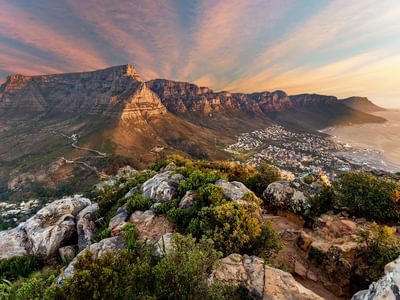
[0, 65, 384, 199]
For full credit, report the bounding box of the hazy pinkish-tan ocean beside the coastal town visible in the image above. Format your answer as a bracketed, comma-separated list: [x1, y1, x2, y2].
[323, 110, 400, 172]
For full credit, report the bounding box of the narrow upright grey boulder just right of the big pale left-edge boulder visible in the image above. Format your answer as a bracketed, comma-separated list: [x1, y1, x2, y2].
[76, 203, 99, 252]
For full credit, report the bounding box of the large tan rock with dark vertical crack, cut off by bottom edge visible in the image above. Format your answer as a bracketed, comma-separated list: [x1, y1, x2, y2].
[209, 254, 323, 300]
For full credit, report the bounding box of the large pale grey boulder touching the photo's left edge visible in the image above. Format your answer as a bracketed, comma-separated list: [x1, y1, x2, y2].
[0, 197, 91, 259]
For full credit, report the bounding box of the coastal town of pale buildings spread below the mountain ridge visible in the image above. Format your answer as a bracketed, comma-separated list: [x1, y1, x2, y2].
[225, 125, 365, 178]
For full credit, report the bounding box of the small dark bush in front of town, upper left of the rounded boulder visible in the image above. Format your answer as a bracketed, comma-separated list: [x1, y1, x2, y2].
[244, 163, 281, 197]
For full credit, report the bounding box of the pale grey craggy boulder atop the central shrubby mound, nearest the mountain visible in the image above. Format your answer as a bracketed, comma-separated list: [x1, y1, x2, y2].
[141, 171, 185, 202]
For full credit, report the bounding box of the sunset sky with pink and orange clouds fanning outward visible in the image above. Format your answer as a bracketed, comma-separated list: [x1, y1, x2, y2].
[0, 0, 400, 107]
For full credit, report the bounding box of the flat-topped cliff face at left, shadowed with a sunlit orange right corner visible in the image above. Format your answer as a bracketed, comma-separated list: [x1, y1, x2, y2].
[0, 65, 166, 118]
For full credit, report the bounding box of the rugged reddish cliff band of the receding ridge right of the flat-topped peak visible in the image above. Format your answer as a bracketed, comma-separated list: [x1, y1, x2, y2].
[146, 79, 337, 114]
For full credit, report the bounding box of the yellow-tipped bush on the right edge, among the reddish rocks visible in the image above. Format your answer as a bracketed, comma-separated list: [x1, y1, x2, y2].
[364, 223, 400, 281]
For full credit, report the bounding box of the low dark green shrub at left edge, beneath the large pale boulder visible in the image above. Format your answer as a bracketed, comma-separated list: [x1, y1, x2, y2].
[0, 255, 42, 280]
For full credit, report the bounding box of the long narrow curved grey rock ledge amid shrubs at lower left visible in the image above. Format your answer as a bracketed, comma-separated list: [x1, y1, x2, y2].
[57, 236, 125, 285]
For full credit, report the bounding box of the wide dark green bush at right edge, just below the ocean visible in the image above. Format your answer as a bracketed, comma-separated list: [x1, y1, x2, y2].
[334, 173, 400, 222]
